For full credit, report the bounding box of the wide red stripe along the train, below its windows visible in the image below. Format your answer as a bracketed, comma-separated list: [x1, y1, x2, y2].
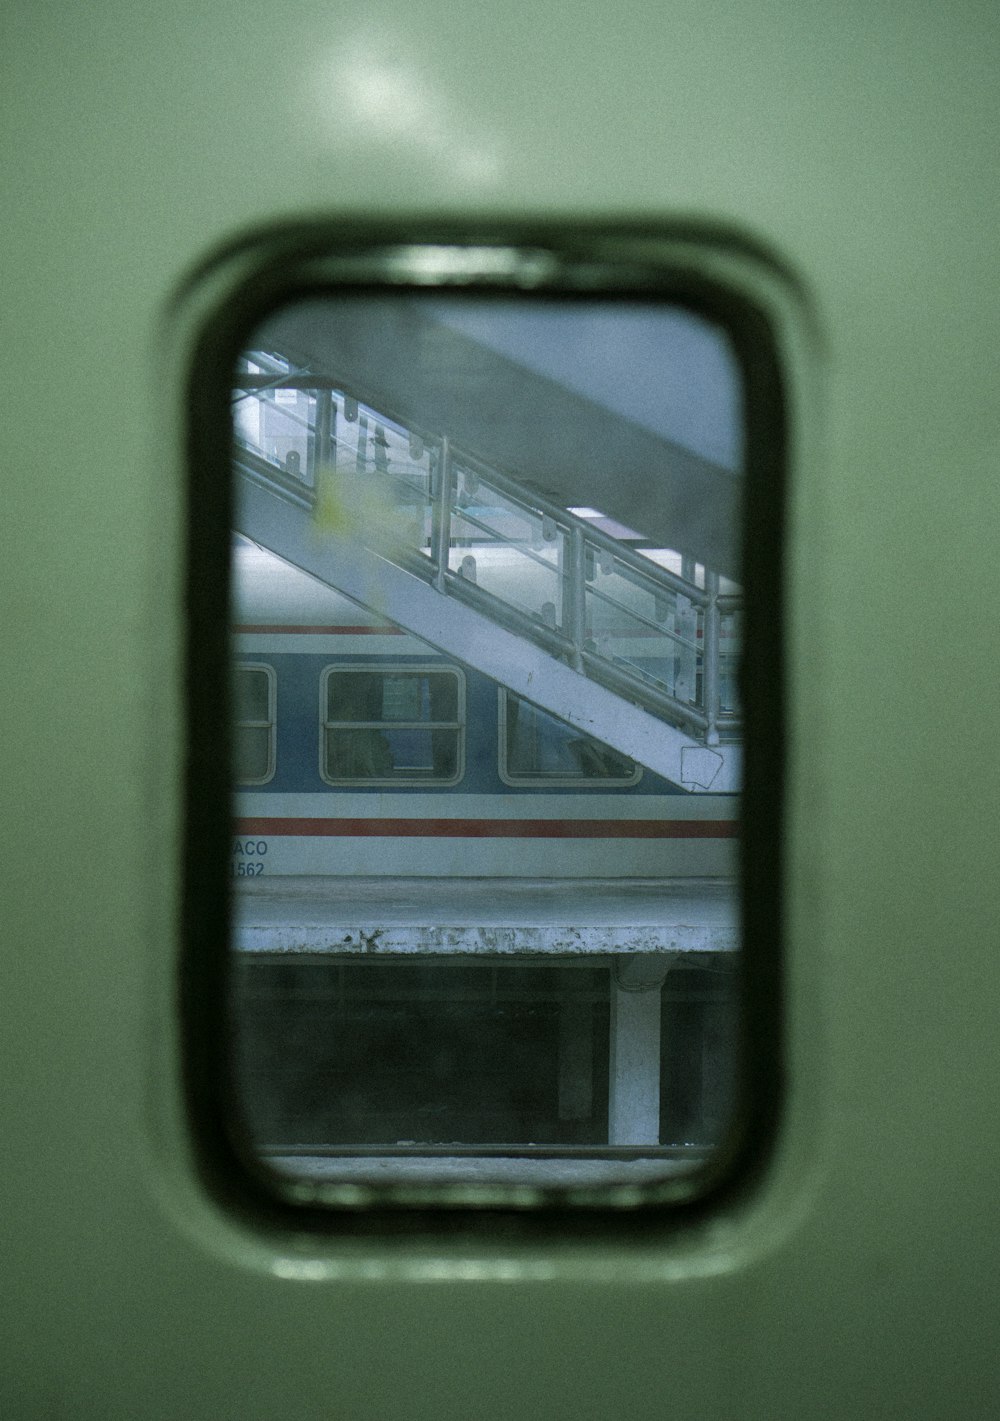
[234, 818, 739, 838]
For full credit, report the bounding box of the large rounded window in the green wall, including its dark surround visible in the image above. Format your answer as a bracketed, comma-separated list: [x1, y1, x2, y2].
[191, 232, 783, 1228]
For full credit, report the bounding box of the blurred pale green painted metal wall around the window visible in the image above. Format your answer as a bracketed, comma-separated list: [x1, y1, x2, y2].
[0, 0, 1000, 1421]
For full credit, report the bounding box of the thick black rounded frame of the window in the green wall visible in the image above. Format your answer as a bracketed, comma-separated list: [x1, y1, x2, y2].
[178, 217, 789, 1245]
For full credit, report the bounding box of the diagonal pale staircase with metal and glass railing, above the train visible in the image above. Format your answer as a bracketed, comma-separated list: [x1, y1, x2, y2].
[233, 339, 741, 793]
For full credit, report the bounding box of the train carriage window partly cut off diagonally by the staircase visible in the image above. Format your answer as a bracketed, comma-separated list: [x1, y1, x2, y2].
[499, 689, 642, 789]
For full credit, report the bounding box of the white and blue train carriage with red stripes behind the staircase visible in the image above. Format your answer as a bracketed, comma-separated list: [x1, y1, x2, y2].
[232, 541, 739, 880]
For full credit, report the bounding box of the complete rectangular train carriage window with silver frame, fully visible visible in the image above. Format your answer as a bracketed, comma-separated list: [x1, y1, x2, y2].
[321, 665, 464, 786]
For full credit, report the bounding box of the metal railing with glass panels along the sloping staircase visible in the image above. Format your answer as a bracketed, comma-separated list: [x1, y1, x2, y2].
[233, 351, 741, 745]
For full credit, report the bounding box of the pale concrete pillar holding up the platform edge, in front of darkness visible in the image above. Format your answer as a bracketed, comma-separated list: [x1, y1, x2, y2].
[608, 953, 672, 1145]
